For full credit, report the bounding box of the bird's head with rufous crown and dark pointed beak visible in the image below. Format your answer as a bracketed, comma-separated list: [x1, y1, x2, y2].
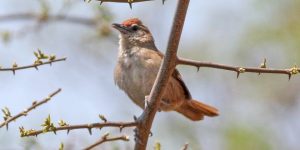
[112, 18, 154, 46]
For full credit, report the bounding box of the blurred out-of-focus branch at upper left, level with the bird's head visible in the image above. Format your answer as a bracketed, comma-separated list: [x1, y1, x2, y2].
[0, 13, 97, 26]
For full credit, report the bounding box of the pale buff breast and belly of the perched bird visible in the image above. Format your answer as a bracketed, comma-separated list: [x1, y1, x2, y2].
[115, 51, 161, 107]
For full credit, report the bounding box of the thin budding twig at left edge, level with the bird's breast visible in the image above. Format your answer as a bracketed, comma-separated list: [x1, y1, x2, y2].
[0, 57, 67, 74]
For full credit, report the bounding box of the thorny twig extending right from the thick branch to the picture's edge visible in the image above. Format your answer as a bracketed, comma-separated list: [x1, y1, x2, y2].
[177, 58, 300, 79]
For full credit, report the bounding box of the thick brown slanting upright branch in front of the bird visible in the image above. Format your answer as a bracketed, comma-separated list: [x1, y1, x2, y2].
[135, 0, 189, 150]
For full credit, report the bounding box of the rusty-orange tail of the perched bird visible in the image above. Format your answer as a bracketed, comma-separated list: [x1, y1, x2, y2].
[176, 100, 219, 121]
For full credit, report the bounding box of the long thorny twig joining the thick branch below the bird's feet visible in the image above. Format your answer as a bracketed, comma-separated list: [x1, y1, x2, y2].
[21, 122, 137, 137]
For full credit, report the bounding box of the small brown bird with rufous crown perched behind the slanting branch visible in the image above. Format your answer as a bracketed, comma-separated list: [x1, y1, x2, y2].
[112, 18, 218, 121]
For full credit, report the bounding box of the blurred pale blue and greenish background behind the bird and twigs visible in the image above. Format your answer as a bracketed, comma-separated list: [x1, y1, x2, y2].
[0, 0, 300, 150]
